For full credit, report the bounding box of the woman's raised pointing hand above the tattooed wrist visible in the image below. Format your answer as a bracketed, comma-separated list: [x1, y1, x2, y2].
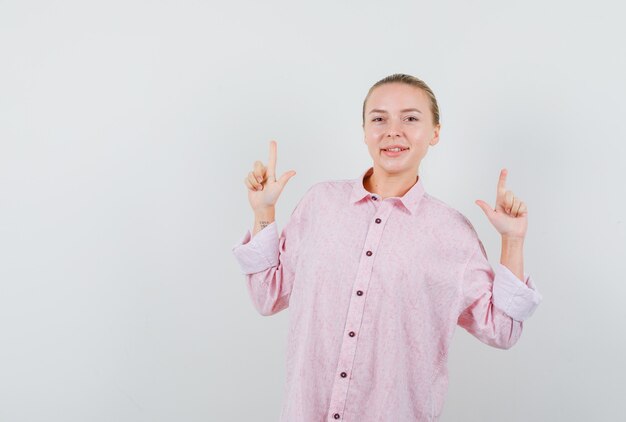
[244, 141, 296, 211]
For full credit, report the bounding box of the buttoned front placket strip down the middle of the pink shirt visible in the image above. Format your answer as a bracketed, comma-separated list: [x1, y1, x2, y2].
[328, 201, 394, 420]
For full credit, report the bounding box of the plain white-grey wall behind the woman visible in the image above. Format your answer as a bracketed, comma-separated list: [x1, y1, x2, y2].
[0, 0, 626, 422]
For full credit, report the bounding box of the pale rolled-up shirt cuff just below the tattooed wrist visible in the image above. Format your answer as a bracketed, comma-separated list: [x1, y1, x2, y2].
[232, 221, 279, 274]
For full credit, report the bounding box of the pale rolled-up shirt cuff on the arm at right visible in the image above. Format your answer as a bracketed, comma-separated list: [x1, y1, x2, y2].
[493, 263, 543, 321]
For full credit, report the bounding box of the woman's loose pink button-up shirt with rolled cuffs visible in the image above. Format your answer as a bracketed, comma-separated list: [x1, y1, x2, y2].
[233, 168, 542, 422]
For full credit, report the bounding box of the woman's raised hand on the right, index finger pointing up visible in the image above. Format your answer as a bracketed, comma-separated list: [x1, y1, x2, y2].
[475, 169, 528, 239]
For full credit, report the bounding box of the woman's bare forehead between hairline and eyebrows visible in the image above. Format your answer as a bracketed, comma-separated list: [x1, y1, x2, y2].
[366, 83, 429, 112]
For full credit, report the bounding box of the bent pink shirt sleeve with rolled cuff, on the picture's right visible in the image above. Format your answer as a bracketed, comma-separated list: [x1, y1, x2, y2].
[458, 239, 542, 349]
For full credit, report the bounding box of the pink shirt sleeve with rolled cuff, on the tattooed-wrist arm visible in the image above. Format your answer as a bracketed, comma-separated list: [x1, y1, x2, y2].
[232, 193, 305, 316]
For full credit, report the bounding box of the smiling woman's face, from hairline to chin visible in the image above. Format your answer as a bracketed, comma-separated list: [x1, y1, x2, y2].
[363, 82, 440, 176]
